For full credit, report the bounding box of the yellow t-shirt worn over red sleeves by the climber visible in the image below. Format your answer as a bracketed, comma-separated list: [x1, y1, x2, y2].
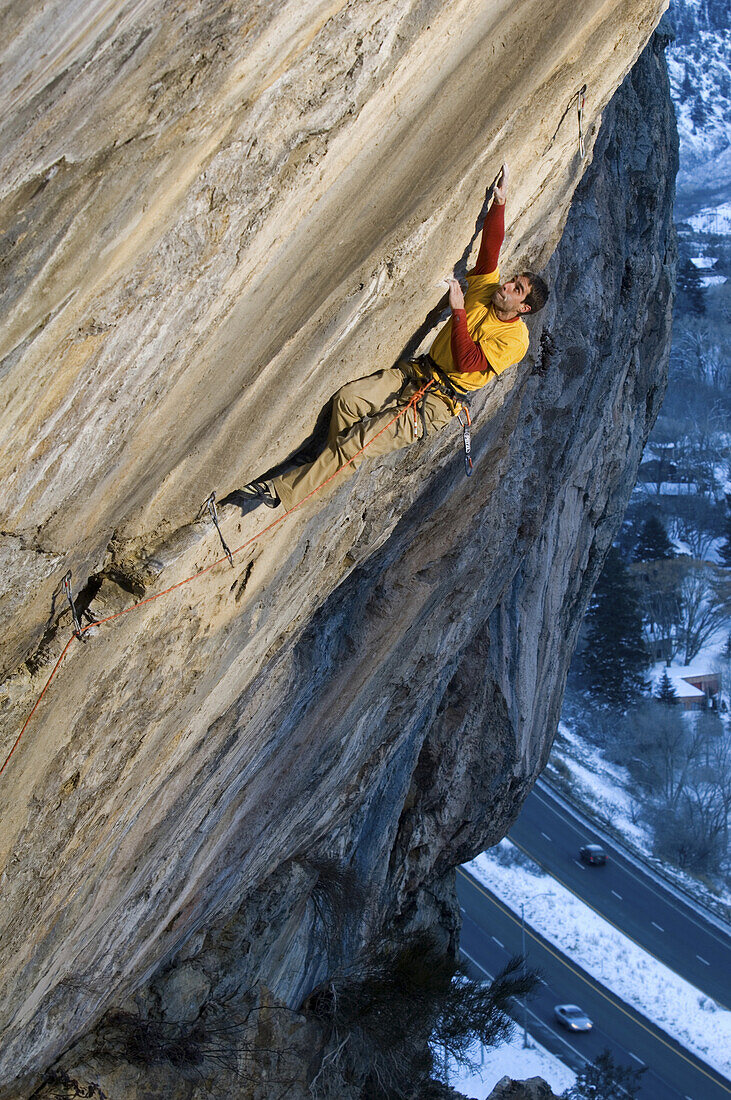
[429, 267, 529, 391]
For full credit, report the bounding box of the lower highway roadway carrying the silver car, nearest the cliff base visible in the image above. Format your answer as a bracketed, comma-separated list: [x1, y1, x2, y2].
[457, 868, 731, 1100]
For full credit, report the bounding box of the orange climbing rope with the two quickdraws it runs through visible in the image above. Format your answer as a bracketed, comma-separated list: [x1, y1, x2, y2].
[0, 378, 434, 776]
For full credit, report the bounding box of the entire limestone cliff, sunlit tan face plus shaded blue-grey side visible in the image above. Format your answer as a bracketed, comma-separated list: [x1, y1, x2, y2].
[0, 0, 675, 1098]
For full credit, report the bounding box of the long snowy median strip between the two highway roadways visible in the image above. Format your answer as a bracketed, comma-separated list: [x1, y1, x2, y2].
[465, 839, 731, 1075]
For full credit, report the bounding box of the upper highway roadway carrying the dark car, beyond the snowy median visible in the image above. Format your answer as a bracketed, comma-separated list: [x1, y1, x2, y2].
[508, 784, 731, 1008]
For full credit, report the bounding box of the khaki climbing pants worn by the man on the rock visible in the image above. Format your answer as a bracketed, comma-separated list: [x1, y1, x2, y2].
[270, 364, 454, 508]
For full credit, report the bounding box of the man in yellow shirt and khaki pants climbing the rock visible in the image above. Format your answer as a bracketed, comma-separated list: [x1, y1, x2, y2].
[221, 164, 549, 514]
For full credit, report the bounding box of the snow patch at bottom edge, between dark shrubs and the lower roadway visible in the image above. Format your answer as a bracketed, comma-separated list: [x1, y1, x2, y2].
[450, 1030, 576, 1100]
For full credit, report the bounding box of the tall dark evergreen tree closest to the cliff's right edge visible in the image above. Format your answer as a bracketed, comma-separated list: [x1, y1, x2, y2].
[583, 547, 649, 706]
